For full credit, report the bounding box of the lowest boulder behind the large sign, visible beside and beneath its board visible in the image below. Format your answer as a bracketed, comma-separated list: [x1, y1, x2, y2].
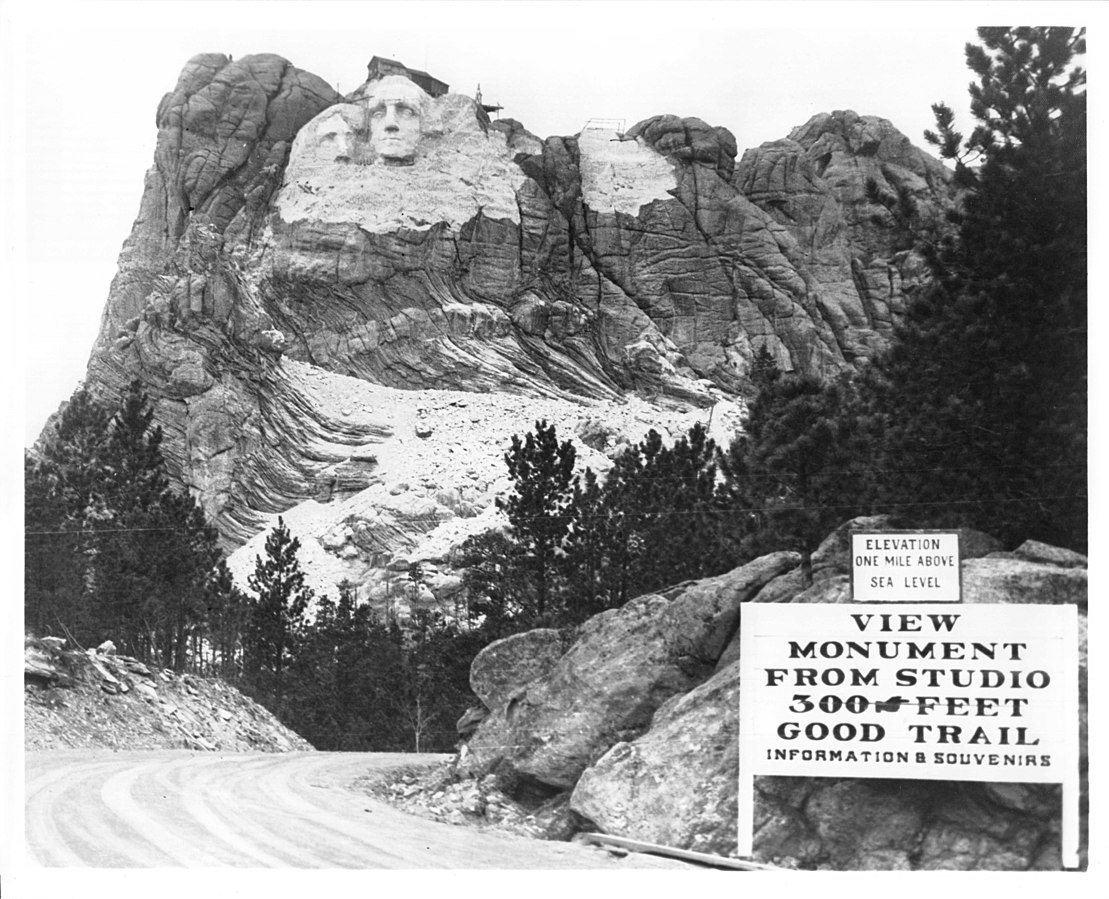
[570, 651, 1059, 870]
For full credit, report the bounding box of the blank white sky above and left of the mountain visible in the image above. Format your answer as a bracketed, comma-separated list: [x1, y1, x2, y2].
[0, 0, 1046, 446]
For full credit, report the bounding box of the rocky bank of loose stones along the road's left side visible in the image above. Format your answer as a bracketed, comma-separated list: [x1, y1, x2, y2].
[23, 637, 314, 752]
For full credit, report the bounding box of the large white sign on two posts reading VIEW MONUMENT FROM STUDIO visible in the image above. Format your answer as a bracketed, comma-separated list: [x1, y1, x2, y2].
[740, 603, 1078, 867]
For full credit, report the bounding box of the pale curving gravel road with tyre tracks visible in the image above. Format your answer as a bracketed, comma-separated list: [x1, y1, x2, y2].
[26, 750, 689, 869]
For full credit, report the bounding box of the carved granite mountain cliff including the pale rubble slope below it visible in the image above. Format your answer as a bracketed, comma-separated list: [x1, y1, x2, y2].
[73, 54, 949, 595]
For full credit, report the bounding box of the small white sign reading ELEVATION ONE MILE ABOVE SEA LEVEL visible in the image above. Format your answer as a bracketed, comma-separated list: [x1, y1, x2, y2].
[851, 531, 962, 602]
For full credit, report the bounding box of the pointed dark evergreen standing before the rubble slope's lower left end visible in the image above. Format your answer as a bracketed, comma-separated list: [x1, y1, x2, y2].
[243, 517, 314, 709]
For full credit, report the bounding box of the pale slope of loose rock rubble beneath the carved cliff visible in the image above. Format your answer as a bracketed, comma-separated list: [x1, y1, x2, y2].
[228, 358, 740, 601]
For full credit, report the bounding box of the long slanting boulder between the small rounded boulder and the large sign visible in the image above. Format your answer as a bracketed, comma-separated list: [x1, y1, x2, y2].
[460, 552, 798, 790]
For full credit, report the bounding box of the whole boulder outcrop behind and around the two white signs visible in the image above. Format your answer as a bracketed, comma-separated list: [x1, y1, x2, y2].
[456, 519, 1089, 870]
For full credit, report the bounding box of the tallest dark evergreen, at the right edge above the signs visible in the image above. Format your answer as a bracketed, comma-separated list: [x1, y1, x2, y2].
[872, 28, 1087, 550]
